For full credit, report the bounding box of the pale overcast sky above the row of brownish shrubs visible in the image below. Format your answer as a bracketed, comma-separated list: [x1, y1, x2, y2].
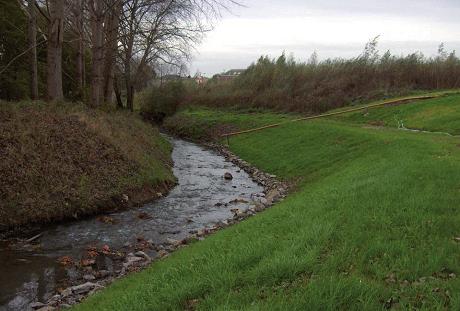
[191, 0, 460, 76]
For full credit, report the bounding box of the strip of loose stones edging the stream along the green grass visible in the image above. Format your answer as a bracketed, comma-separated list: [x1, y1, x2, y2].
[18, 138, 290, 310]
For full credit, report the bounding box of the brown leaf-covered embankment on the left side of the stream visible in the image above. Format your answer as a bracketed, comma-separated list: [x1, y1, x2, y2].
[0, 102, 174, 229]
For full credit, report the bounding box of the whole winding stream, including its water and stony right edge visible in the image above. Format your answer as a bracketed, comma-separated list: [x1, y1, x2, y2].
[0, 139, 288, 311]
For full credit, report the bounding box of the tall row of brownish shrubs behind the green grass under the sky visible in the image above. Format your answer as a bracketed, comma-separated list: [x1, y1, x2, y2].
[189, 39, 460, 114]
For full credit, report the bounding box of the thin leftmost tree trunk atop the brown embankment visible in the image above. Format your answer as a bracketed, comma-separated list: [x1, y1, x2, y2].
[28, 0, 38, 100]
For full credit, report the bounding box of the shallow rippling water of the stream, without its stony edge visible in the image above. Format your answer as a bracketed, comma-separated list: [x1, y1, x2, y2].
[0, 140, 263, 311]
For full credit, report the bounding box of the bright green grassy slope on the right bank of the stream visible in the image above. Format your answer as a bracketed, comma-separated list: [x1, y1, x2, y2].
[76, 96, 460, 310]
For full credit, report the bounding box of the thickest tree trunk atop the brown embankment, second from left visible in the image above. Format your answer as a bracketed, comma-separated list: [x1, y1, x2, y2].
[47, 0, 64, 101]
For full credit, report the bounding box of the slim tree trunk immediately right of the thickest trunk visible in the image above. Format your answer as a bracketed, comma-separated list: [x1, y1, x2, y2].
[76, 0, 85, 100]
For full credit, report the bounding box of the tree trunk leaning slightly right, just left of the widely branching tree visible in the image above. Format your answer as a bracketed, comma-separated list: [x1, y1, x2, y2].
[104, 3, 122, 102]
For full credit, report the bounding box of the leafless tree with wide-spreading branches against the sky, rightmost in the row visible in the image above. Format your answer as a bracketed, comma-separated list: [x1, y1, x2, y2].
[120, 0, 236, 110]
